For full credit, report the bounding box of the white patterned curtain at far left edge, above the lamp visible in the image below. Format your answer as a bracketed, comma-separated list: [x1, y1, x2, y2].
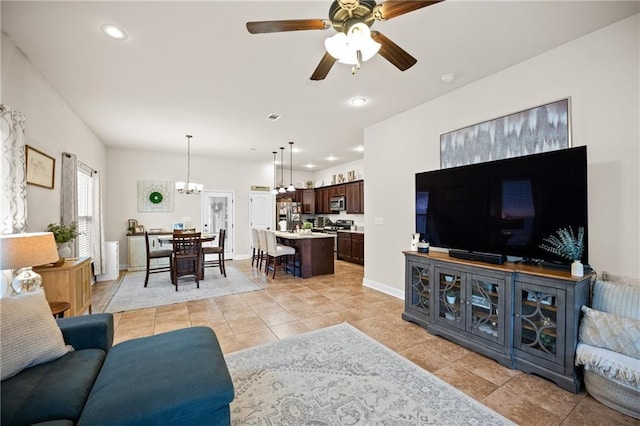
[0, 105, 27, 234]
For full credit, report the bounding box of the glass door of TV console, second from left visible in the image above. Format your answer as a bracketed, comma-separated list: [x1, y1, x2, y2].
[434, 268, 465, 328]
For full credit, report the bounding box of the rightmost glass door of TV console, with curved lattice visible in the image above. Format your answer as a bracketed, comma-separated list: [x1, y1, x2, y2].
[514, 282, 565, 362]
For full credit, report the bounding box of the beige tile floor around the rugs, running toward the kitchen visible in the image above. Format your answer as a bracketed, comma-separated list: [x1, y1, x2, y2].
[93, 260, 640, 426]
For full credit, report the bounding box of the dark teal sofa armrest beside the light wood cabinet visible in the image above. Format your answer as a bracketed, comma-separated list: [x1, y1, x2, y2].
[56, 313, 113, 352]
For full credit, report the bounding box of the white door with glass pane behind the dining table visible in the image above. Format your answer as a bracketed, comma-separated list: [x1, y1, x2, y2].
[202, 191, 234, 260]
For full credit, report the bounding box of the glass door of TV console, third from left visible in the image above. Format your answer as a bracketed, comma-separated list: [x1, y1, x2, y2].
[466, 275, 505, 344]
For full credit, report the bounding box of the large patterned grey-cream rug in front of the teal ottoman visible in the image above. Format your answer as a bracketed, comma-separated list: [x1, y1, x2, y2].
[226, 323, 513, 426]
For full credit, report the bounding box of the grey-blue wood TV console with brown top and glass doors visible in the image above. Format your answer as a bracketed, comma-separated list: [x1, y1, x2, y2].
[402, 252, 593, 392]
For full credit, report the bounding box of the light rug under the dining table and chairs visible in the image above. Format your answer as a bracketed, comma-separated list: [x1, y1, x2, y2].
[104, 264, 262, 312]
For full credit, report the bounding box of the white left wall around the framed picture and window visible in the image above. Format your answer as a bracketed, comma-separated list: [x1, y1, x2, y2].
[1, 34, 108, 232]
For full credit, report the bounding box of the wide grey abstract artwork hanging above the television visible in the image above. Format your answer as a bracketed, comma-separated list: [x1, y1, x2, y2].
[440, 98, 571, 169]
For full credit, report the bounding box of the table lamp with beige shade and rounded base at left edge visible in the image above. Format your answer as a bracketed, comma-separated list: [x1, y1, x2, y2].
[0, 232, 59, 293]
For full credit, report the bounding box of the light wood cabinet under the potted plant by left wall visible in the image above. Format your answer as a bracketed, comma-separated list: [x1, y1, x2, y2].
[34, 257, 91, 316]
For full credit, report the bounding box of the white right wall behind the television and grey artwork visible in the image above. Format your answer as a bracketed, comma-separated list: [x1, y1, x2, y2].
[364, 15, 640, 297]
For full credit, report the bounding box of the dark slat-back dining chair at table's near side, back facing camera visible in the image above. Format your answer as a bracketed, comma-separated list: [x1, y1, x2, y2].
[171, 232, 202, 291]
